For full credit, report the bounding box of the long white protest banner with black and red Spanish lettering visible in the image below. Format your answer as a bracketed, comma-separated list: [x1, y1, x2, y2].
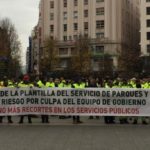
[0, 88, 150, 116]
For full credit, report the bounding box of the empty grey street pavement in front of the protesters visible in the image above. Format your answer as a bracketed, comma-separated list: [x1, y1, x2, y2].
[0, 117, 150, 150]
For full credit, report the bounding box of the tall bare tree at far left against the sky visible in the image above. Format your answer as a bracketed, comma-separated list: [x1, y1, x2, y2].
[0, 18, 21, 76]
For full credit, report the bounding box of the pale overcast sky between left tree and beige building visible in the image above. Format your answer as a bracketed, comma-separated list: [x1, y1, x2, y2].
[0, 0, 40, 63]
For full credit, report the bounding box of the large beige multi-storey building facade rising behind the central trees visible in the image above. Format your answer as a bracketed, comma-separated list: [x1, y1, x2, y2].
[34, 0, 140, 71]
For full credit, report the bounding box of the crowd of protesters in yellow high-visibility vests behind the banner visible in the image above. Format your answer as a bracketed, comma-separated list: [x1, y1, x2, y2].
[0, 75, 150, 124]
